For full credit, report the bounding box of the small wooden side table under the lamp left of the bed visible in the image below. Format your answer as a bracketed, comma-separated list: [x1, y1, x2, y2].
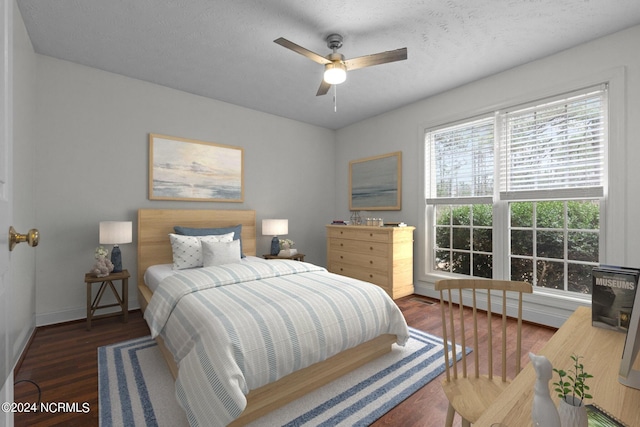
[84, 270, 129, 331]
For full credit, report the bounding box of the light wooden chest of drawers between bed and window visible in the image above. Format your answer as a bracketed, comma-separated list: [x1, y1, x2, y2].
[327, 225, 415, 299]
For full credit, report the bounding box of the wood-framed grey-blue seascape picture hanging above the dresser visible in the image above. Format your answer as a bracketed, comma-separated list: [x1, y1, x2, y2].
[349, 151, 402, 211]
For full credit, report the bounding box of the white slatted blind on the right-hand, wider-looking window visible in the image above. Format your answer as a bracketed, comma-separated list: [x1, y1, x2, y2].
[500, 87, 607, 200]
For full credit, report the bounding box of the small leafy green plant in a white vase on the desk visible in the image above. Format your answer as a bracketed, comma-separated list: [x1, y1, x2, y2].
[553, 354, 593, 427]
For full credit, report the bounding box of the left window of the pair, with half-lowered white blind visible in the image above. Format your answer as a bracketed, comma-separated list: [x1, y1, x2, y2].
[427, 117, 495, 278]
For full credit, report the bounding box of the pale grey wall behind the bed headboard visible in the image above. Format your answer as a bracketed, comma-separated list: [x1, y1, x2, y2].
[34, 55, 335, 325]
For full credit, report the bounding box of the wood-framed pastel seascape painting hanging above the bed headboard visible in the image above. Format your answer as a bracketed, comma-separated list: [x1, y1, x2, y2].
[149, 134, 244, 202]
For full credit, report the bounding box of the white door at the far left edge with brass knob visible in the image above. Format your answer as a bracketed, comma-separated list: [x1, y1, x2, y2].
[0, 0, 14, 426]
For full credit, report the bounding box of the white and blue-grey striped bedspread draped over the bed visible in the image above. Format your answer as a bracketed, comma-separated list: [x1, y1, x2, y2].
[145, 259, 409, 426]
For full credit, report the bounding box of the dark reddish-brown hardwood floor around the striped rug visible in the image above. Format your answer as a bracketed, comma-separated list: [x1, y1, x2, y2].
[14, 296, 555, 427]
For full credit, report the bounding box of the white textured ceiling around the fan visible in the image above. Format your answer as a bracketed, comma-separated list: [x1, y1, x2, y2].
[17, 0, 640, 129]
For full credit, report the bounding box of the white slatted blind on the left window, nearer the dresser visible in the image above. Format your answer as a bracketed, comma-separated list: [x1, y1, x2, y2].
[425, 116, 495, 204]
